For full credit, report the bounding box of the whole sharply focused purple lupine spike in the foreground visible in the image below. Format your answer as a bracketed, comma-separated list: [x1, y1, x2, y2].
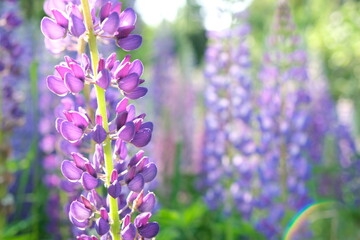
[41, 0, 159, 240]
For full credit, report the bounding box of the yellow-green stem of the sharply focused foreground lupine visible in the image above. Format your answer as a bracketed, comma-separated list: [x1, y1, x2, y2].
[81, 0, 120, 240]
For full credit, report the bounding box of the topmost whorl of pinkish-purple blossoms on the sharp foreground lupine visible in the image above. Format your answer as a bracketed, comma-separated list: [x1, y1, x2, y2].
[41, 0, 142, 54]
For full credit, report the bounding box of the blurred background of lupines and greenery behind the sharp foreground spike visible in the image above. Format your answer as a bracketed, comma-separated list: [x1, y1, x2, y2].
[0, 0, 360, 240]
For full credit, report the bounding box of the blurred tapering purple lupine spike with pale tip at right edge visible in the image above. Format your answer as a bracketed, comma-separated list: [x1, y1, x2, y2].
[308, 57, 360, 205]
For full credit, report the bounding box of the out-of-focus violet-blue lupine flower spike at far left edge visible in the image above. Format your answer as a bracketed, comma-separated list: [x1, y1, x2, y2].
[0, 1, 29, 221]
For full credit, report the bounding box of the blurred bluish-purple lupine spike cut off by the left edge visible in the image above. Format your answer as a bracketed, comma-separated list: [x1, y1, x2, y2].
[0, 1, 27, 232]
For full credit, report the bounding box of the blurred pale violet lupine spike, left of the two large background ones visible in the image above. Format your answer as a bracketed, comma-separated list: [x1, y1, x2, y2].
[202, 13, 256, 215]
